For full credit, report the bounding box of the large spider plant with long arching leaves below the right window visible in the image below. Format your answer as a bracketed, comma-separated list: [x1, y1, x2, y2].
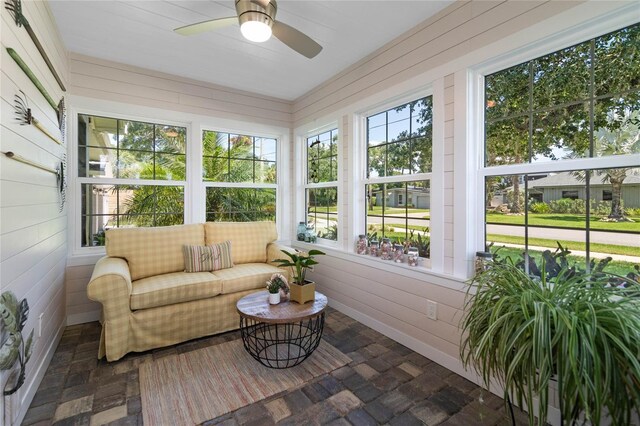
[460, 261, 640, 425]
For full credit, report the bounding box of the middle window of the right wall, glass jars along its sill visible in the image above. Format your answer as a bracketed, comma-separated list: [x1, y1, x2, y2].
[365, 96, 433, 257]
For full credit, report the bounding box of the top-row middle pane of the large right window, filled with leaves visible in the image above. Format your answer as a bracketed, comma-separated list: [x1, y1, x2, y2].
[532, 42, 591, 109]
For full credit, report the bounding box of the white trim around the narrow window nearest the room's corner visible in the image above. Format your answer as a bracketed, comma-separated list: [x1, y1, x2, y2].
[298, 121, 347, 249]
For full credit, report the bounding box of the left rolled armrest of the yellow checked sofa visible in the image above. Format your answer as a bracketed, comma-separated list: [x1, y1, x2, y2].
[87, 256, 131, 321]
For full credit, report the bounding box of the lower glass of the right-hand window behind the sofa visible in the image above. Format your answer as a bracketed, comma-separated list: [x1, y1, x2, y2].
[206, 188, 276, 222]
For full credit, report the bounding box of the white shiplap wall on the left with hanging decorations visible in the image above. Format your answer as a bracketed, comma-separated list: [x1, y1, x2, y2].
[0, 1, 68, 425]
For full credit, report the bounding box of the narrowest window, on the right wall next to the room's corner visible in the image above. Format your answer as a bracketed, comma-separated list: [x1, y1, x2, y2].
[305, 129, 338, 241]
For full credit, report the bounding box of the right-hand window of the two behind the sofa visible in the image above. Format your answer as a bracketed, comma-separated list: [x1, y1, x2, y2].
[202, 130, 277, 222]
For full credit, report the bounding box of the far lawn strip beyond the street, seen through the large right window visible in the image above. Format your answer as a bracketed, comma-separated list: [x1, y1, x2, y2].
[487, 213, 640, 233]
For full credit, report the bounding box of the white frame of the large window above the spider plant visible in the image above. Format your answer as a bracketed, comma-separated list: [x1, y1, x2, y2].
[470, 20, 640, 278]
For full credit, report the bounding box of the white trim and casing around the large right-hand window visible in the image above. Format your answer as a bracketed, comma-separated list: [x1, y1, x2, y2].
[464, 10, 640, 278]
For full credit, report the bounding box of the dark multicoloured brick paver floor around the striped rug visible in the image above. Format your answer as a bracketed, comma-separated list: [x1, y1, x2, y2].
[23, 309, 528, 426]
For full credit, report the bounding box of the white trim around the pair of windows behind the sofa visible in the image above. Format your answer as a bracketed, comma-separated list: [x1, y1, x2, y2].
[66, 95, 291, 258]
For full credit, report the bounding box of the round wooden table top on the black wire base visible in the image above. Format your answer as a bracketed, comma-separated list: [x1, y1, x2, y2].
[236, 290, 327, 324]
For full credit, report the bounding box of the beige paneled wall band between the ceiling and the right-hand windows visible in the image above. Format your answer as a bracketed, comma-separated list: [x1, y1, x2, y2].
[293, 0, 579, 123]
